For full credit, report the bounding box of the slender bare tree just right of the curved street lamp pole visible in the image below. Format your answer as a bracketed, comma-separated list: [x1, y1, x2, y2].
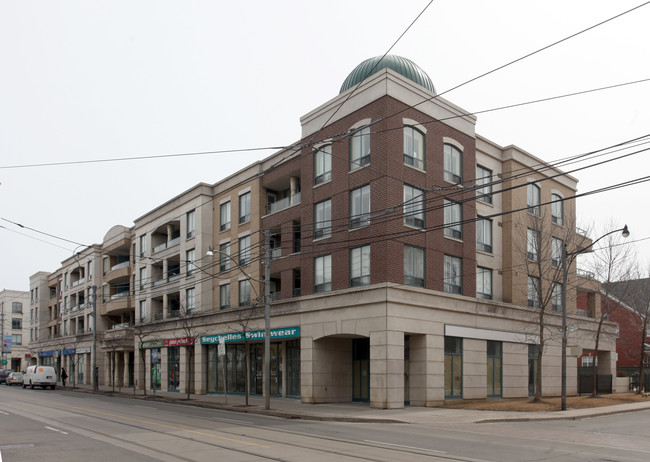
[580, 221, 633, 398]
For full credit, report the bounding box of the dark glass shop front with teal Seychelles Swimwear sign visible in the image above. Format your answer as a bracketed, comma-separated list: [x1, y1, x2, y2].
[201, 327, 300, 397]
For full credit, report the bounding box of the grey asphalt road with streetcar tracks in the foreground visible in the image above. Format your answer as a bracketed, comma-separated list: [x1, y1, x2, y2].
[0, 386, 650, 462]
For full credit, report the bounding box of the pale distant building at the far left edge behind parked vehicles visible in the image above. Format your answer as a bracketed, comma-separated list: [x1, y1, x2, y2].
[0, 289, 30, 371]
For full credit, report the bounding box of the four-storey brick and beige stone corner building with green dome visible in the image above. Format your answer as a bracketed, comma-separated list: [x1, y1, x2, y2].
[22, 56, 615, 408]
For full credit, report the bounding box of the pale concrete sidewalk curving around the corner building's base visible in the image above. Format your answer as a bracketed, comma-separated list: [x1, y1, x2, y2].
[57, 385, 650, 424]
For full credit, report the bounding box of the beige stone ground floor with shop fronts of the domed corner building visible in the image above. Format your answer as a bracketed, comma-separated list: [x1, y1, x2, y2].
[134, 286, 616, 408]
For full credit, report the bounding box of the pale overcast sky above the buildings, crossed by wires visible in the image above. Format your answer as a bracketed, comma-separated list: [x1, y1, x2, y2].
[0, 0, 650, 290]
